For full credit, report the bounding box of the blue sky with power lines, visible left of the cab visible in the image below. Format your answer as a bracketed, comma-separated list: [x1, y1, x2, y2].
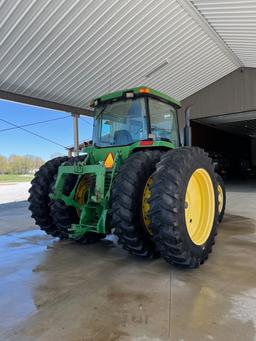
[0, 100, 92, 160]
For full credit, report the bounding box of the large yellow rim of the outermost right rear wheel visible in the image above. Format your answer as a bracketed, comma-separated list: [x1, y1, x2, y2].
[185, 168, 215, 245]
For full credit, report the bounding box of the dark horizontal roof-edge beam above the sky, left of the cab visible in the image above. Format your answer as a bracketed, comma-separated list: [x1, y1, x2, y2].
[0, 90, 94, 117]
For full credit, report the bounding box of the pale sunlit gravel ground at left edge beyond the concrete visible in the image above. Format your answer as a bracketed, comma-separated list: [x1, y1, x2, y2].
[0, 182, 31, 204]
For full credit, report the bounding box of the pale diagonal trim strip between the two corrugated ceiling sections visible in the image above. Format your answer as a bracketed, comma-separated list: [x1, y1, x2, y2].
[176, 0, 244, 67]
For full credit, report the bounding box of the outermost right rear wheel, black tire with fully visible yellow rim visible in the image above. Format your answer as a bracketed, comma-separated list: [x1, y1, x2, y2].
[148, 147, 218, 268]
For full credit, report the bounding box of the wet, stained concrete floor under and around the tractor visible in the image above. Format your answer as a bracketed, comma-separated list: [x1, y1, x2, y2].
[0, 183, 256, 341]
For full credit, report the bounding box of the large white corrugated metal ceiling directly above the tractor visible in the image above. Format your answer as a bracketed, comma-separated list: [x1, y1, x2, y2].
[0, 0, 251, 112]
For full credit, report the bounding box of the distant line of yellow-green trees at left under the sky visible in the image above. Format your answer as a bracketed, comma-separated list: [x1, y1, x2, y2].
[0, 155, 45, 174]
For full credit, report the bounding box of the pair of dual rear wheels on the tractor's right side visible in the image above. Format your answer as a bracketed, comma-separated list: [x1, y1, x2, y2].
[112, 147, 219, 268]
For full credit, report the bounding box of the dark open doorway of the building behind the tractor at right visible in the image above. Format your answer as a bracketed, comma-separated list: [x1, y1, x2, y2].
[191, 112, 256, 178]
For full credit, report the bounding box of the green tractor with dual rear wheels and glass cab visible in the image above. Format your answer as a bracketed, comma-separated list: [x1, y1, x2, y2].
[29, 86, 225, 268]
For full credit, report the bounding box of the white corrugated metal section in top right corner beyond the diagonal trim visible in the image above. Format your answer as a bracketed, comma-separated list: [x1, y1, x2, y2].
[192, 0, 256, 67]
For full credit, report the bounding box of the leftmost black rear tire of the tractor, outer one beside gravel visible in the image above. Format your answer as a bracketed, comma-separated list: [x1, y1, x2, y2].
[28, 157, 68, 237]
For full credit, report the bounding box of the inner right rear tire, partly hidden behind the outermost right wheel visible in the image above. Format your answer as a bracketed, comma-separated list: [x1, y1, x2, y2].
[111, 150, 161, 258]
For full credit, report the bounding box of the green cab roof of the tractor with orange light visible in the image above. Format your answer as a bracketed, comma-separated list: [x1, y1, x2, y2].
[93, 85, 181, 108]
